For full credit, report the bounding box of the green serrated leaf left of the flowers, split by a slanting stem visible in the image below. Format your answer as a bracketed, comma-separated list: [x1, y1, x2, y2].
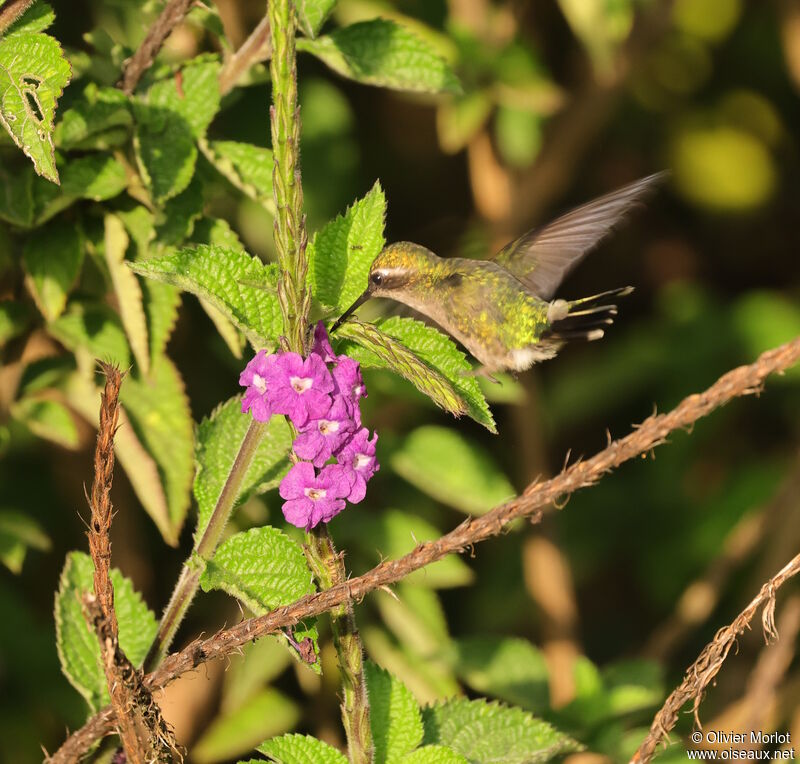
[194, 396, 292, 539]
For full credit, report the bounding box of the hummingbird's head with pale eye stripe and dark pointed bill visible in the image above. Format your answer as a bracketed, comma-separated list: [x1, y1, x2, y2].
[330, 241, 438, 332]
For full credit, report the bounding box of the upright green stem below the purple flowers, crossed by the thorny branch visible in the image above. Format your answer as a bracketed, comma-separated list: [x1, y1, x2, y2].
[305, 525, 373, 764]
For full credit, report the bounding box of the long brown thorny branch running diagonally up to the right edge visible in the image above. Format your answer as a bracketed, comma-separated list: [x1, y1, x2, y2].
[50, 337, 800, 764]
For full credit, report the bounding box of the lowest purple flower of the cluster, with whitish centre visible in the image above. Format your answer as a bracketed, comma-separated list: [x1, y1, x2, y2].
[279, 462, 351, 531]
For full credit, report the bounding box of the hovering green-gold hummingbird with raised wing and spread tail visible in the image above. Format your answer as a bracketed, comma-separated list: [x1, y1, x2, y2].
[331, 173, 664, 379]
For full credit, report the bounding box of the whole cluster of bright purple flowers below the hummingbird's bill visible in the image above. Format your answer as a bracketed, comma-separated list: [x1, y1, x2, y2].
[239, 322, 379, 530]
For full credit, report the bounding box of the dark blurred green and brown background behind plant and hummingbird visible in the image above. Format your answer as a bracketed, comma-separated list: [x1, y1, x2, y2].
[0, 0, 800, 762]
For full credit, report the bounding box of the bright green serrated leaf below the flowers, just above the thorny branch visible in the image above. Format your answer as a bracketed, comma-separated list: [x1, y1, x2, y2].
[200, 525, 316, 615]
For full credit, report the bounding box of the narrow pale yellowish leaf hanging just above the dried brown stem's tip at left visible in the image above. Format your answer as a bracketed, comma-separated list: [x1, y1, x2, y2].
[103, 215, 150, 374]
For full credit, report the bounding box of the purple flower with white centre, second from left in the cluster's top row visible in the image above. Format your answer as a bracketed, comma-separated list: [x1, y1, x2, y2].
[266, 353, 333, 427]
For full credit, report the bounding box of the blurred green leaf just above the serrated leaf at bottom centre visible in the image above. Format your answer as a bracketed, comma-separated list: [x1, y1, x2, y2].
[452, 636, 550, 713]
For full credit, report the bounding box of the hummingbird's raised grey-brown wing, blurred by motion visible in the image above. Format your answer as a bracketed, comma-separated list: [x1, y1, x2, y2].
[492, 172, 665, 300]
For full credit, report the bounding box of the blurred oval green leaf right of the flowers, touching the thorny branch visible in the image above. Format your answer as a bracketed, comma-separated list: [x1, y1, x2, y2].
[391, 425, 516, 515]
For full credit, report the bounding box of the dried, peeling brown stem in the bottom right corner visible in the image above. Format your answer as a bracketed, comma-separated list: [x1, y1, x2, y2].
[631, 548, 800, 764]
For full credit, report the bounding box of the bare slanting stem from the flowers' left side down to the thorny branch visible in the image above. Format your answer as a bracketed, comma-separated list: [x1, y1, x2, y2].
[144, 420, 266, 671]
